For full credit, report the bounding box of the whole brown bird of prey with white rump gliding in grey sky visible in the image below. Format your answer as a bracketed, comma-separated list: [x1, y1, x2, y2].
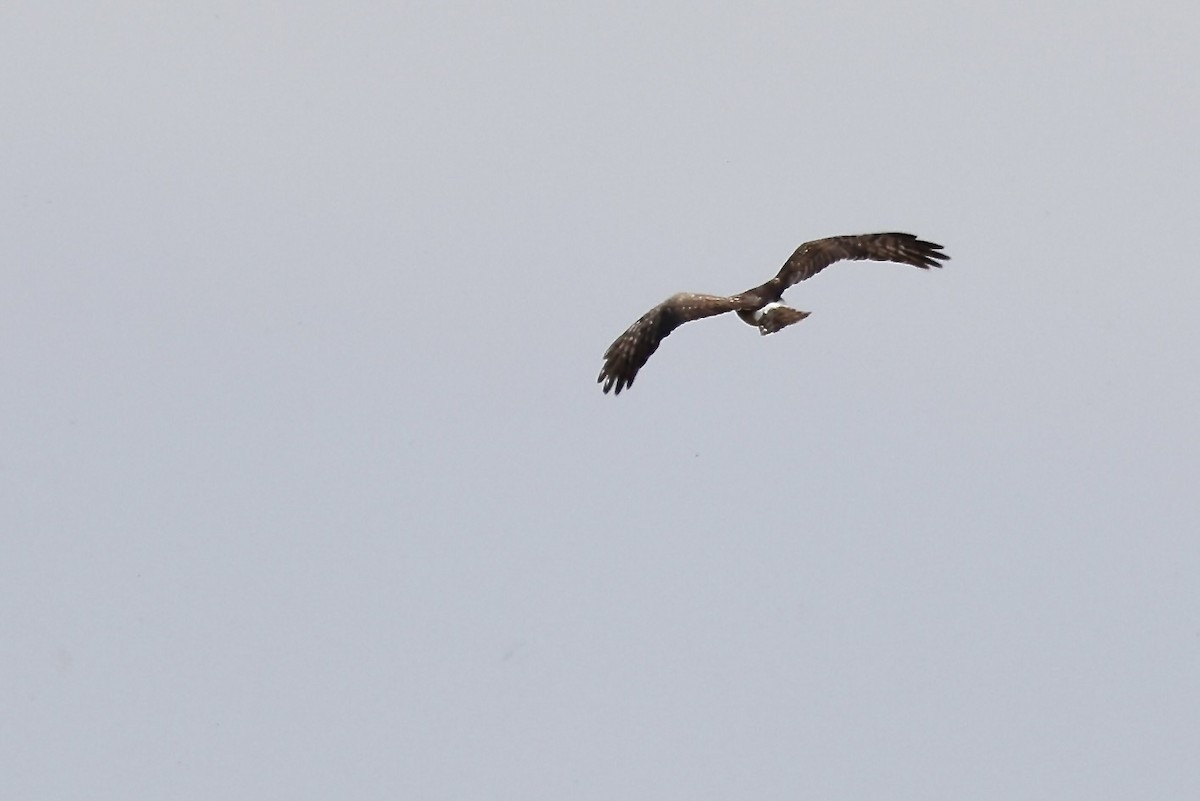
[596, 234, 950, 395]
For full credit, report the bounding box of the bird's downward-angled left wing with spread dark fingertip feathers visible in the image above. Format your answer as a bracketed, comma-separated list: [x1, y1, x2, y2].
[596, 293, 754, 395]
